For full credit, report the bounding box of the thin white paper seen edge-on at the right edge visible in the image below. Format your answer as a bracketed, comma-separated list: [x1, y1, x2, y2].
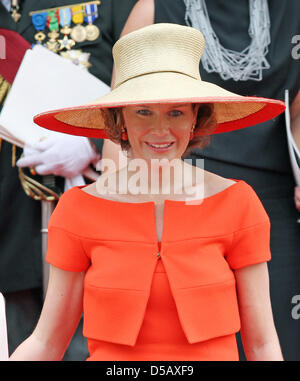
[285, 90, 300, 186]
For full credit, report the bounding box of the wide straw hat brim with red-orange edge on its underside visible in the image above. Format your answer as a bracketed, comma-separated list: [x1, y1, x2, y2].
[34, 72, 285, 138]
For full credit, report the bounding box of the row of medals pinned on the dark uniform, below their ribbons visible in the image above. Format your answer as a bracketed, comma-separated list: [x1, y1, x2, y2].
[34, 15, 100, 53]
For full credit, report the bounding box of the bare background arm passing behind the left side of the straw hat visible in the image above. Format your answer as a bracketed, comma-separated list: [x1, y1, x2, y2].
[102, 0, 154, 169]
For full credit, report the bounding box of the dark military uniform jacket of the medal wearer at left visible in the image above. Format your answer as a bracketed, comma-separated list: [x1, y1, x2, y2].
[0, 0, 135, 293]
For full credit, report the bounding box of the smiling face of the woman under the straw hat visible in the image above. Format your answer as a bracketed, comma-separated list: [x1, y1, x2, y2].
[123, 103, 198, 160]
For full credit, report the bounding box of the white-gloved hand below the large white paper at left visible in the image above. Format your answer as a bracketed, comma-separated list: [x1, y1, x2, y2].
[16, 134, 101, 178]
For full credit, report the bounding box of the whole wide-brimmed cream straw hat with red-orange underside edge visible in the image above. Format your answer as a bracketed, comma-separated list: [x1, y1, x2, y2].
[34, 23, 285, 138]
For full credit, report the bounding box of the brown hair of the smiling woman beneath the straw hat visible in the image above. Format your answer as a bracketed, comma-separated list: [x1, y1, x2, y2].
[101, 103, 217, 155]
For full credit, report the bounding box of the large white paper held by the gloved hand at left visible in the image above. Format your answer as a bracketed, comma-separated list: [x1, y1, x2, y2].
[0, 45, 110, 147]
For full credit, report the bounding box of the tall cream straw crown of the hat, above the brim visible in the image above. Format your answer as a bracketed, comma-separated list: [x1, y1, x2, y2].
[113, 23, 205, 88]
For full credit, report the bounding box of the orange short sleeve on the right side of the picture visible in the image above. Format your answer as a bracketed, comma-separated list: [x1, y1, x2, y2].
[226, 183, 271, 270]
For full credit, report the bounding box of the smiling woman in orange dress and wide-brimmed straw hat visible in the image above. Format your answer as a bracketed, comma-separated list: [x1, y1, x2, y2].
[10, 24, 284, 361]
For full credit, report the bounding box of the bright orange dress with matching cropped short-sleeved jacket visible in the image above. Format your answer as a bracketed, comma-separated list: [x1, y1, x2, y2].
[46, 180, 271, 361]
